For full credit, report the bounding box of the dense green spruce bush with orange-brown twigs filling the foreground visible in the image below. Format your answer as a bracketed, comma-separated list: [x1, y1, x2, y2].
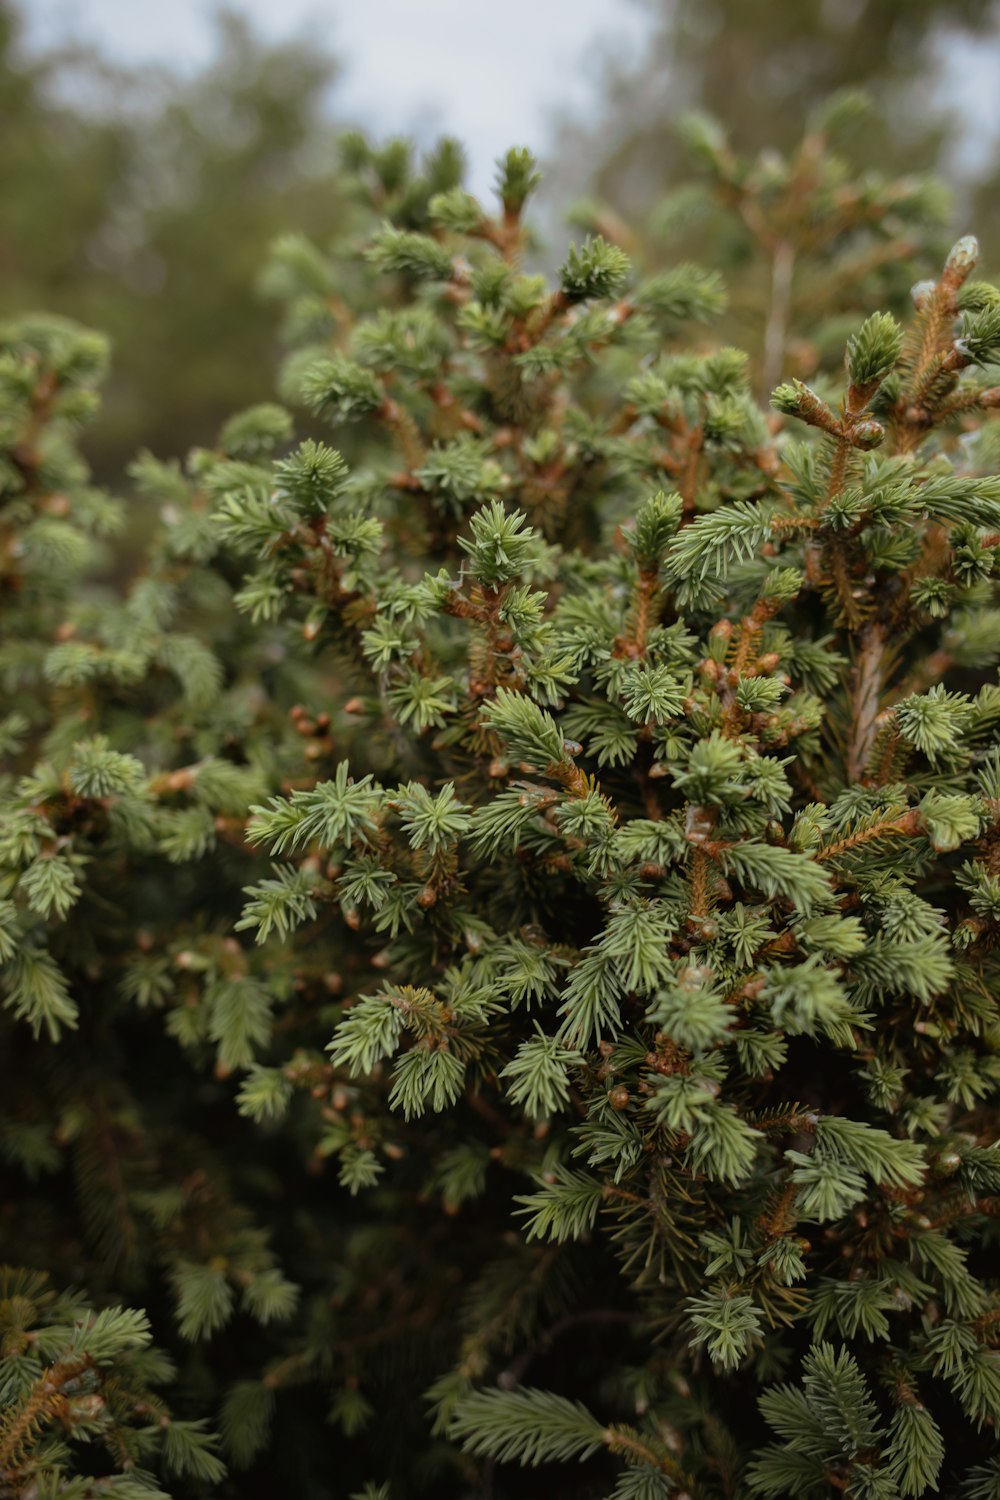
[0, 140, 1000, 1500]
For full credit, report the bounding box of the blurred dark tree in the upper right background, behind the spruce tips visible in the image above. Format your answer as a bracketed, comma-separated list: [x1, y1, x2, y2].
[559, 0, 999, 216]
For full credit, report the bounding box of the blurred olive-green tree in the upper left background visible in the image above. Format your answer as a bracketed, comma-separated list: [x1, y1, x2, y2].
[0, 0, 352, 477]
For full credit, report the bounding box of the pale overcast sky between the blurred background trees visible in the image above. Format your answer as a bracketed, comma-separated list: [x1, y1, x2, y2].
[24, 0, 648, 194]
